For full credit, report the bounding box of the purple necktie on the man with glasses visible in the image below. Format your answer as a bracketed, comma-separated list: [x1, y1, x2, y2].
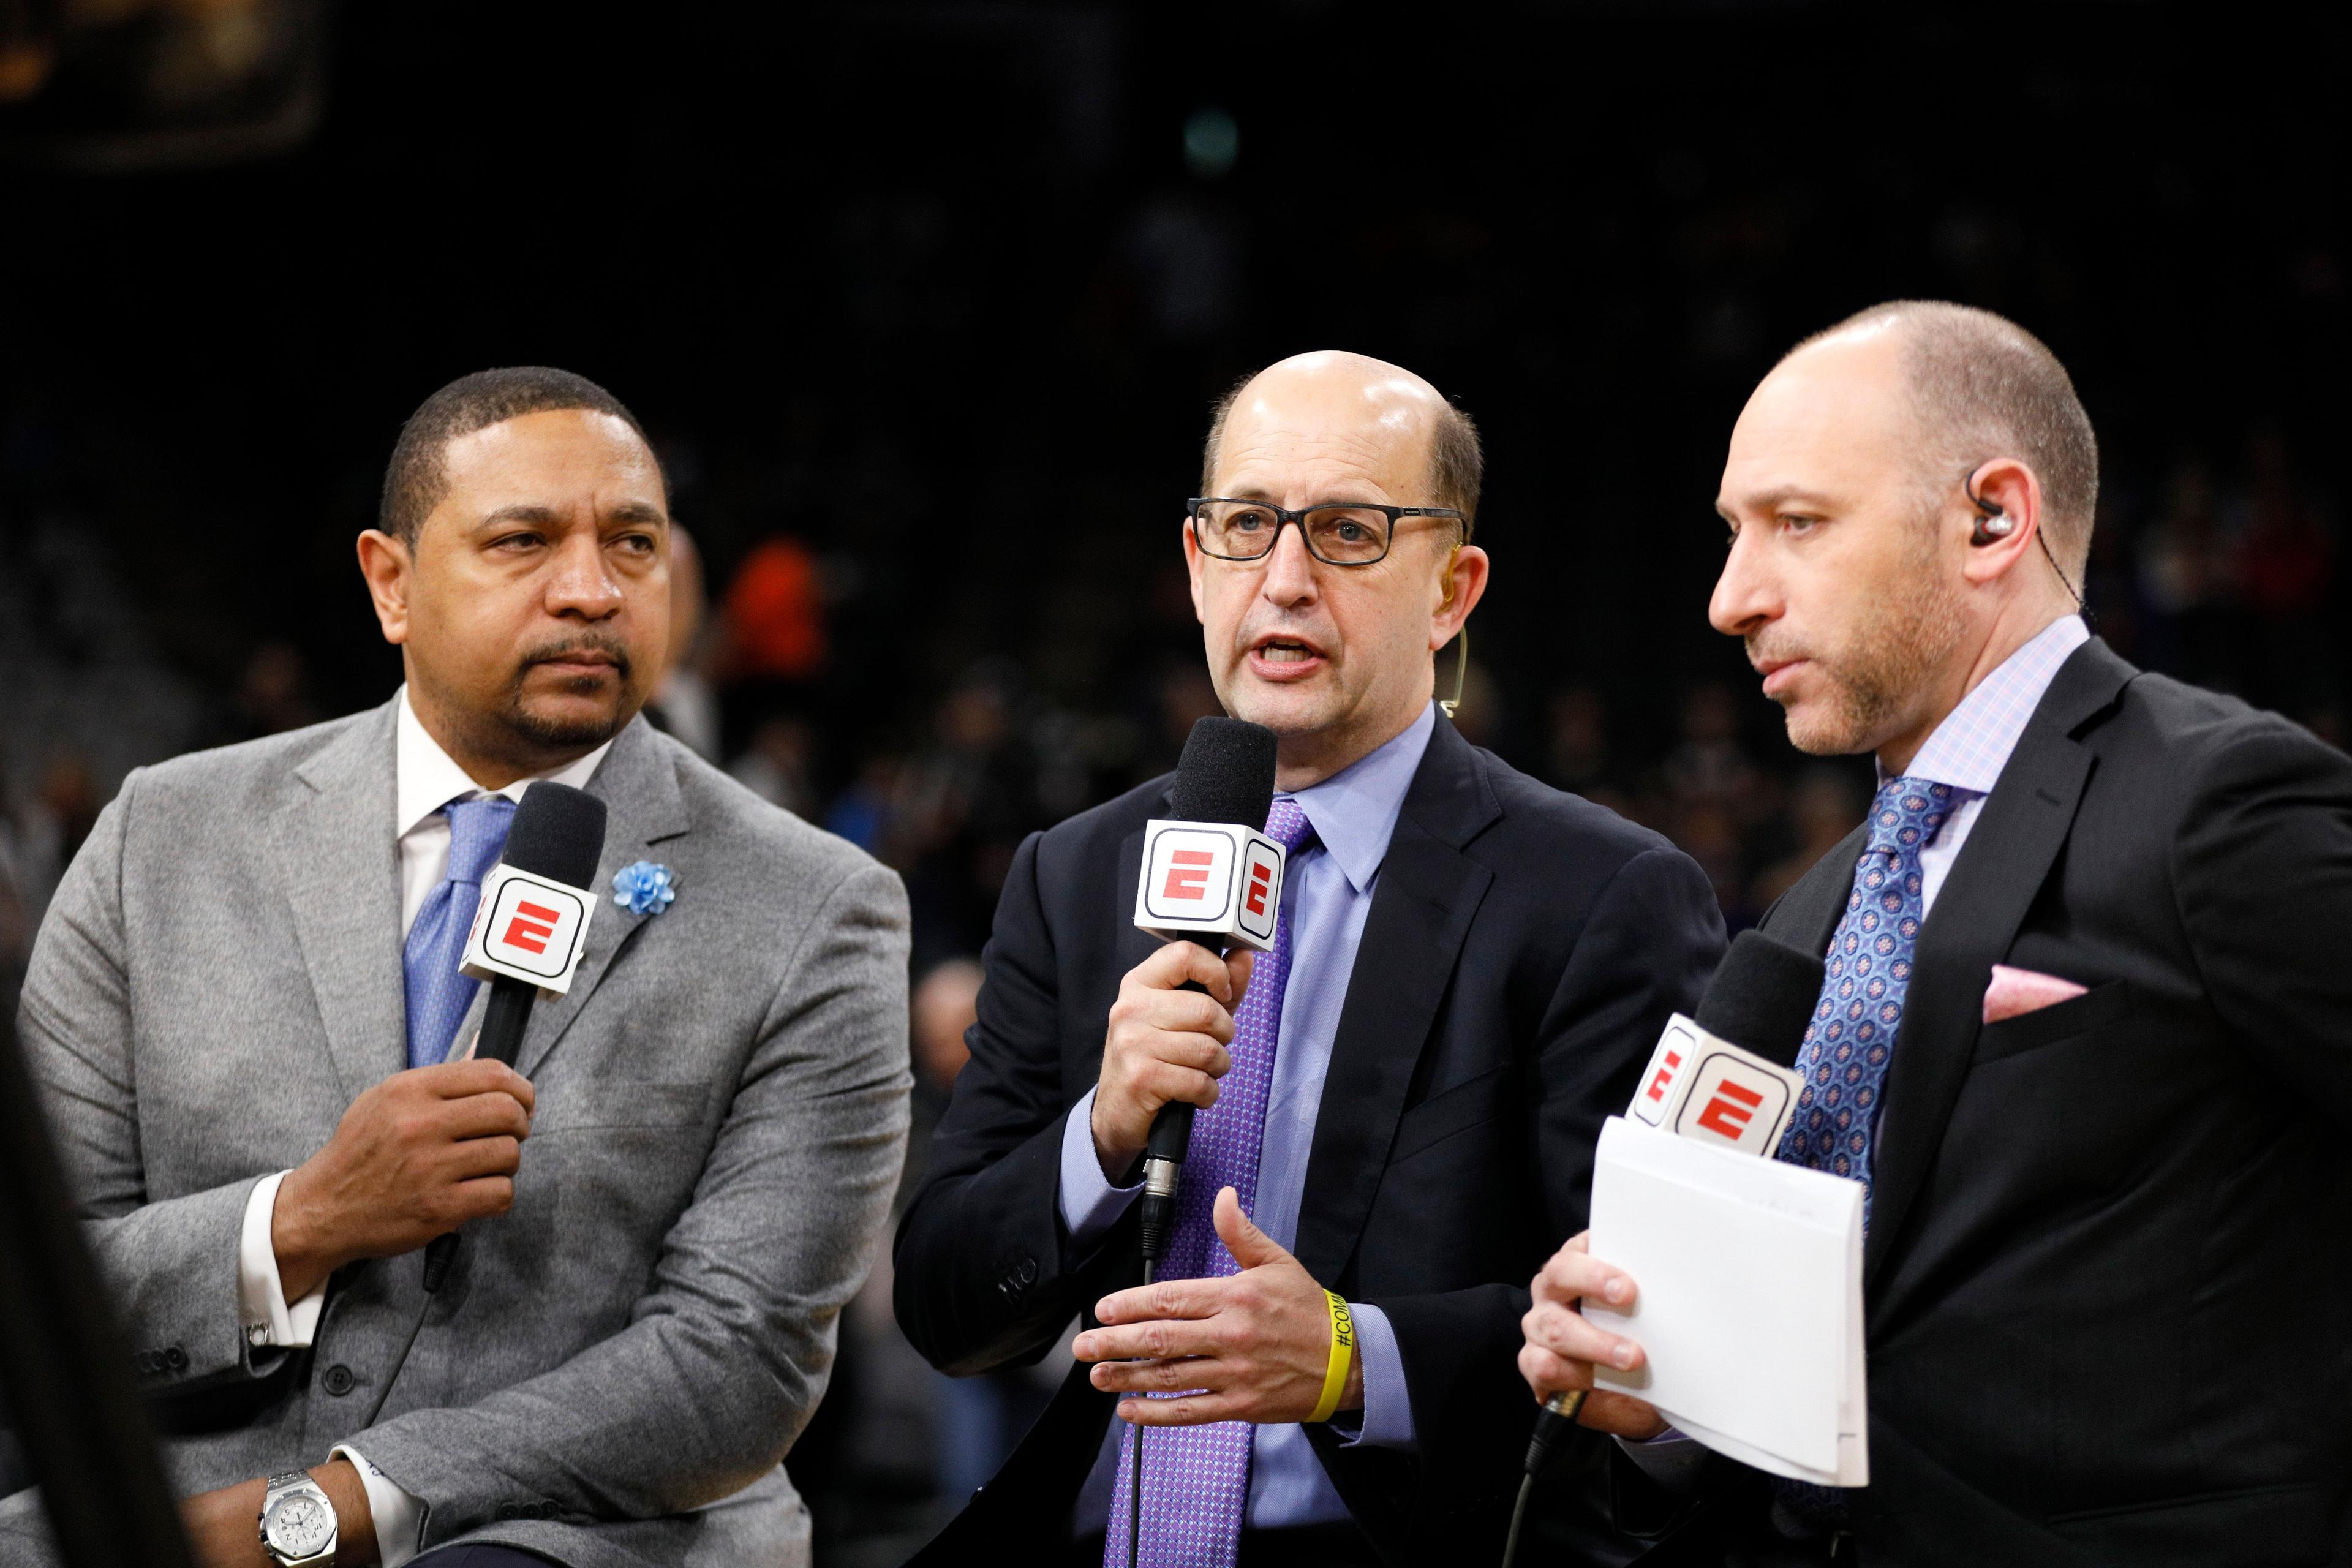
[1103, 794, 1315, 1568]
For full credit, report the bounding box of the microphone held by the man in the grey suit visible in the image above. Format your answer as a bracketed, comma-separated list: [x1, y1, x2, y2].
[426, 780, 605, 1293]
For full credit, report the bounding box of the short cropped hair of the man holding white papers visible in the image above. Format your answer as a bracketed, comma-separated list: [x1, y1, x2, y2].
[1790, 298, 2098, 583]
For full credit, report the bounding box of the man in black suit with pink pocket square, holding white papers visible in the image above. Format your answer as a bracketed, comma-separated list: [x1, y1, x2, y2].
[1521, 303, 2352, 1568]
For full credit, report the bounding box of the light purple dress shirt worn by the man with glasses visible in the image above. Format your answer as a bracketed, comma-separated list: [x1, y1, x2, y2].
[1061, 703, 1437, 1535]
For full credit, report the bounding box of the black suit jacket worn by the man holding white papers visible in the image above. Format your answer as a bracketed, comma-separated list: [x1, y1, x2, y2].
[1616, 639, 2352, 1568]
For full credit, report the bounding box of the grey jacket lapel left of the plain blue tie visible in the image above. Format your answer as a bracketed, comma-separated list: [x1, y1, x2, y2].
[273, 698, 409, 1102]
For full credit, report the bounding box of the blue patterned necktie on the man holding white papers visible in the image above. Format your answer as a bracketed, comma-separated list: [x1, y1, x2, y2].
[1773, 778, 1962, 1532]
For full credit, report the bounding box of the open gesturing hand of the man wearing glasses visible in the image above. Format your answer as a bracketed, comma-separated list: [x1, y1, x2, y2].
[1075, 1187, 1364, 1427]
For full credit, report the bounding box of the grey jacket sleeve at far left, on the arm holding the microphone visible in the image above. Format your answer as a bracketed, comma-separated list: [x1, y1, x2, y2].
[17, 774, 287, 1394]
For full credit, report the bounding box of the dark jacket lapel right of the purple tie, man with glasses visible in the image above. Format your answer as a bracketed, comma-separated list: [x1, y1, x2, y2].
[1296, 722, 1501, 1279]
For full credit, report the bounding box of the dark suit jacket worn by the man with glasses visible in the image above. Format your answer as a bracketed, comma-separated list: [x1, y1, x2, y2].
[896, 724, 1724, 1563]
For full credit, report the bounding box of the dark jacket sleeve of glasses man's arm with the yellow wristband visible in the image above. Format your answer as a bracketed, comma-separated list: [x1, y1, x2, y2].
[1376, 849, 1724, 1490]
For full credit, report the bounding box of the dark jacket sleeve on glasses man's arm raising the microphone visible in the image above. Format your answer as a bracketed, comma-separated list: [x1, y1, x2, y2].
[894, 835, 1136, 1375]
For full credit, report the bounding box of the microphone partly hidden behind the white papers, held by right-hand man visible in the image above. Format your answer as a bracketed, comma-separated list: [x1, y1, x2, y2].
[1503, 931, 1823, 1568]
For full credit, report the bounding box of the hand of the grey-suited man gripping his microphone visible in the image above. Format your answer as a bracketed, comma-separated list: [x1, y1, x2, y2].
[271, 1060, 532, 1302]
